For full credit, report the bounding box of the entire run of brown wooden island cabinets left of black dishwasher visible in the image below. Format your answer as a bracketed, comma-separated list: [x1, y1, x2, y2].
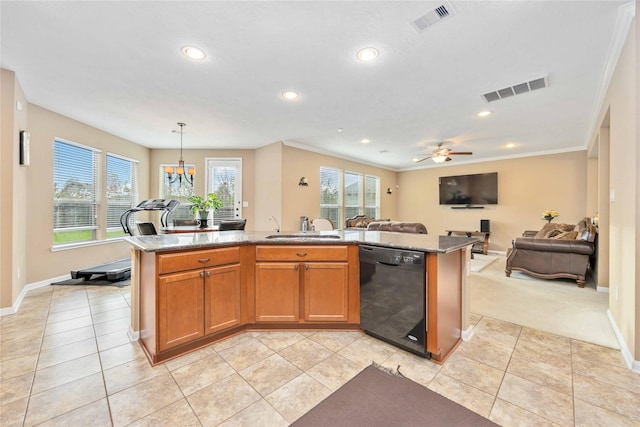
[136, 244, 360, 364]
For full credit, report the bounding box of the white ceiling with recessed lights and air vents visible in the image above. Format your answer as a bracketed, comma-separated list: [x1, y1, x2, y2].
[0, 0, 629, 170]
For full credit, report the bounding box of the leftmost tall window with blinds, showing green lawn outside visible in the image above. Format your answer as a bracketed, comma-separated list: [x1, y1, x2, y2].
[53, 139, 101, 245]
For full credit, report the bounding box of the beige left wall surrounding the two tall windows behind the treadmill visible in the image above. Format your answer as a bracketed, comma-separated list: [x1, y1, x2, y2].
[23, 104, 149, 288]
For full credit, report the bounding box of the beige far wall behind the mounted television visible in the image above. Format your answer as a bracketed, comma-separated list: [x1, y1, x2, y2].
[397, 151, 595, 252]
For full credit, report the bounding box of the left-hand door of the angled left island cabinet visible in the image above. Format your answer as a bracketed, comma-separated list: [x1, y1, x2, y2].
[158, 270, 204, 351]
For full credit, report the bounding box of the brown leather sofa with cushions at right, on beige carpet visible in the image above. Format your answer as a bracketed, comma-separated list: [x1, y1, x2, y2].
[505, 218, 596, 288]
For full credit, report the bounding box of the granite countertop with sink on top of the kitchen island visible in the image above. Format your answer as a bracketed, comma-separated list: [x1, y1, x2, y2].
[125, 230, 480, 253]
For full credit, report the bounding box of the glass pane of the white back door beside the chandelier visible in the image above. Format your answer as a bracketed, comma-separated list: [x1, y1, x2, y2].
[205, 158, 242, 225]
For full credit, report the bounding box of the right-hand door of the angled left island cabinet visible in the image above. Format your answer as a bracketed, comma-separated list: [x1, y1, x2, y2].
[204, 264, 241, 334]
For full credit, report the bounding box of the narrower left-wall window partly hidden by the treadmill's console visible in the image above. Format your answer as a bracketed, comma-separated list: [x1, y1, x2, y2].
[106, 153, 138, 238]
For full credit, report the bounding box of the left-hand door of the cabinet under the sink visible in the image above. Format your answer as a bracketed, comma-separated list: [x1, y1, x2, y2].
[256, 262, 300, 322]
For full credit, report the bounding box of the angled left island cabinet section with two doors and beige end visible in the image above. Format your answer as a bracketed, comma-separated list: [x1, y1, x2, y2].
[140, 247, 242, 362]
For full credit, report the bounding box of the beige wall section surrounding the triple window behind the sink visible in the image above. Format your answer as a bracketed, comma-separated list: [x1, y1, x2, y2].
[281, 144, 397, 230]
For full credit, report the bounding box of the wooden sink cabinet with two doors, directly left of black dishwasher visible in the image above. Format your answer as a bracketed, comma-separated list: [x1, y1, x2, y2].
[255, 245, 359, 323]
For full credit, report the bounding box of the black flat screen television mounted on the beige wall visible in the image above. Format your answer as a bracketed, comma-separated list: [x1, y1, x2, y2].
[439, 172, 498, 205]
